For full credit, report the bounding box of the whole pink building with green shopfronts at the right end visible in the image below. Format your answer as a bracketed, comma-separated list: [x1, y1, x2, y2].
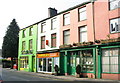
[60, 0, 120, 80]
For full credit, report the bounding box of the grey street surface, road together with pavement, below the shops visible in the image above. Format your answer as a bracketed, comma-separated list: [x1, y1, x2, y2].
[2, 68, 120, 83]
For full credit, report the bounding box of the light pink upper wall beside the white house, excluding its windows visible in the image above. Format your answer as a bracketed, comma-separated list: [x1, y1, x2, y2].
[60, 3, 94, 45]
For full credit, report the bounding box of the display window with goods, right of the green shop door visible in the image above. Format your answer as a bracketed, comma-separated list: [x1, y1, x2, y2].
[80, 50, 94, 72]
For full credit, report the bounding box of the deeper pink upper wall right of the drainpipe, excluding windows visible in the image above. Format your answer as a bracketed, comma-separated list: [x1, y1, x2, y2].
[94, 0, 120, 40]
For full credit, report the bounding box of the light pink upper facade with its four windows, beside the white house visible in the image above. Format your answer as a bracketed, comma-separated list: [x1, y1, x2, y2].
[60, 3, 94, 45]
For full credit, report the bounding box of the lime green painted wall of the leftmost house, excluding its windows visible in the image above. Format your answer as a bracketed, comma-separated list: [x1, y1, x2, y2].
[18, 25, 37, 71]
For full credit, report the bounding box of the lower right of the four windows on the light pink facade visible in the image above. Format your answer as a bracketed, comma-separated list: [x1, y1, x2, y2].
[79, 26, 87, 42]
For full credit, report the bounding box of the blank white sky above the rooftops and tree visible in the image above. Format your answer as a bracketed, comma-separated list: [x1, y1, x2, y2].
[0, 0, 88, 49]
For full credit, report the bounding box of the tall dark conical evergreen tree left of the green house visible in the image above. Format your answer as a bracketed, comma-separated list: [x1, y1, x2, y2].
[2, 19, 20, 68]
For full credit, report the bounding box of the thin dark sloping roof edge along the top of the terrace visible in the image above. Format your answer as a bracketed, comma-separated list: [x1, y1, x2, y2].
[20, 0, 91, 31]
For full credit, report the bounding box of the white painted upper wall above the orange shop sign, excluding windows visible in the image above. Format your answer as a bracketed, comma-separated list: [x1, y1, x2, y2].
[37, 15, 60, 51]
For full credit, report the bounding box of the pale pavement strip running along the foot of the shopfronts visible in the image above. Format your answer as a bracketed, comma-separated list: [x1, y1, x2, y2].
[5, 68, 120, 83]
